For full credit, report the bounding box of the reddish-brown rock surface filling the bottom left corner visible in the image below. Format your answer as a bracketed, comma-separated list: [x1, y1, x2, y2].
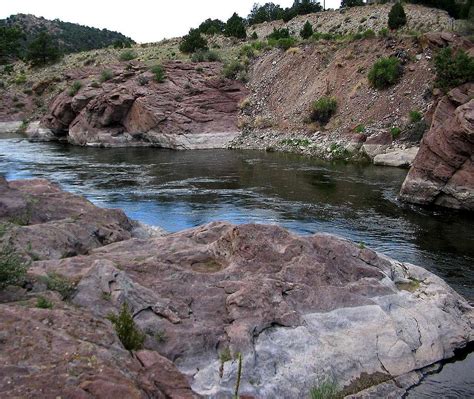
[0, 292, 198, 399]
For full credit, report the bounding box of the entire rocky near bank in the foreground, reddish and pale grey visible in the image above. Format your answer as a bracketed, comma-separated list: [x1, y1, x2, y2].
[0, 180, 474, 398]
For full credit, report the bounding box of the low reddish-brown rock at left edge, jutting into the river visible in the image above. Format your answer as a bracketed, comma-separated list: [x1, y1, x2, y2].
[0, 178, 138, 260]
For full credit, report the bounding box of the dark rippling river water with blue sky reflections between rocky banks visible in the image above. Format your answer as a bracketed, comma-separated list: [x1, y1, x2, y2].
[0, 137, 474, 398]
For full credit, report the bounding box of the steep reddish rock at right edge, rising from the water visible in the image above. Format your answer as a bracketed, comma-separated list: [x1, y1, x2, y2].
[400, 83, 474, 210]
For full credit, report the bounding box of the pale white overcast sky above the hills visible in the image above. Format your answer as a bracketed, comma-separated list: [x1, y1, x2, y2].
[0, 0, 340, 43]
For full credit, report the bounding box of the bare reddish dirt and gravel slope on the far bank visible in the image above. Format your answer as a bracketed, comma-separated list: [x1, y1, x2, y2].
[233, 29, 472, 164]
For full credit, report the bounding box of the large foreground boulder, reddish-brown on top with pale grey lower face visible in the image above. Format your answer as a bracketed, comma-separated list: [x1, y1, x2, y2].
[32, 222, 474, 398]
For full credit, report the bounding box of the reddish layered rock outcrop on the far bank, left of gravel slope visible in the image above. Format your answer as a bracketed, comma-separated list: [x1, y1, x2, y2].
[35, 61, 250, 149]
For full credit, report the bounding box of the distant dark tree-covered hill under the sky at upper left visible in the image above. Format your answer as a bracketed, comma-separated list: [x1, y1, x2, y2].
[0, 14, 134, 53]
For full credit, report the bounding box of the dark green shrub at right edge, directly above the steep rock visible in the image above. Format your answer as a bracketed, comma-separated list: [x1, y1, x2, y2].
[435, 47, 474, 91]
